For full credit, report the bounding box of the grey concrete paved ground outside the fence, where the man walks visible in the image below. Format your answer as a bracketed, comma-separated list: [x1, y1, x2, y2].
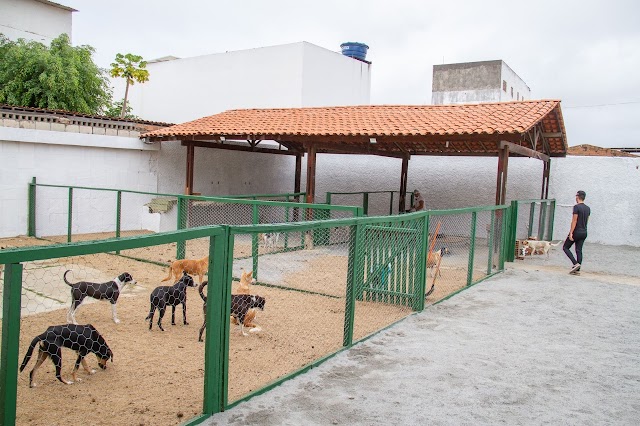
[206, 244, 640, 425]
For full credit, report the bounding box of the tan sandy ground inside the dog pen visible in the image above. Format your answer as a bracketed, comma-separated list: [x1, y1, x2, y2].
[0, 238, 411, 425]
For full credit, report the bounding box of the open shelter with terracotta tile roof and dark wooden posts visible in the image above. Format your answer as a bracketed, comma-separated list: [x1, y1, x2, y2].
[141, 100, 568, 210]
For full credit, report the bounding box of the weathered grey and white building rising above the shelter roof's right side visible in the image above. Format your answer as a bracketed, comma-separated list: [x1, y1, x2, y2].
[431, 60, 531, 105]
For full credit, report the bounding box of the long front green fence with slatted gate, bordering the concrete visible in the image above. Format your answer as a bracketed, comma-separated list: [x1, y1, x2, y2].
[0, 200, 510, 424]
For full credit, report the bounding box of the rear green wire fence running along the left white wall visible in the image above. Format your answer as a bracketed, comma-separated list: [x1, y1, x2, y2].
[27, 178, 362, 263]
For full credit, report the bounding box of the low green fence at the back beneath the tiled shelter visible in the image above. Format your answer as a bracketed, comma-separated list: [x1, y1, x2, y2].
[326, 191, 413, 216]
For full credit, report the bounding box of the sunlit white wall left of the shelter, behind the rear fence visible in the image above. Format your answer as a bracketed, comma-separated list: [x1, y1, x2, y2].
[0, 127, 158, 237]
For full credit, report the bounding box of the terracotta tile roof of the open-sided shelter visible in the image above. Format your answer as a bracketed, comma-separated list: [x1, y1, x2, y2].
[141, 100, 567, 156]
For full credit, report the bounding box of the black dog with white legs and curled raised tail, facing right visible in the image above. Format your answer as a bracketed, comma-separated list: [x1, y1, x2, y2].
[63, 269, 136, 324]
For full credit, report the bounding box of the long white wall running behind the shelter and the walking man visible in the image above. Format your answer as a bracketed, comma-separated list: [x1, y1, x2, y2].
[0, 127, 640, 247]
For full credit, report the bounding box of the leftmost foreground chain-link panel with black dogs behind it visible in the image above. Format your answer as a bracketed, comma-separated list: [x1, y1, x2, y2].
[0, 231, 222, 425]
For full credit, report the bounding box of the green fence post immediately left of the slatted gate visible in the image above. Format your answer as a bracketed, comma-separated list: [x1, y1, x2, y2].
[342, 224, 364, 346]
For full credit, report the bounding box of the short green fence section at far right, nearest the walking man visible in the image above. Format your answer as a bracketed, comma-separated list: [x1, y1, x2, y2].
[507, 199, 556, 262]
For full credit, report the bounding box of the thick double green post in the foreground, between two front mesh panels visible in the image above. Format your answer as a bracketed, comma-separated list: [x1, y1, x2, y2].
[202, 226, 233, 416]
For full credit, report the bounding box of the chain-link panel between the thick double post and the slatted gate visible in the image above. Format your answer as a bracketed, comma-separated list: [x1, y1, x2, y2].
[228, 226, 352, 402]
